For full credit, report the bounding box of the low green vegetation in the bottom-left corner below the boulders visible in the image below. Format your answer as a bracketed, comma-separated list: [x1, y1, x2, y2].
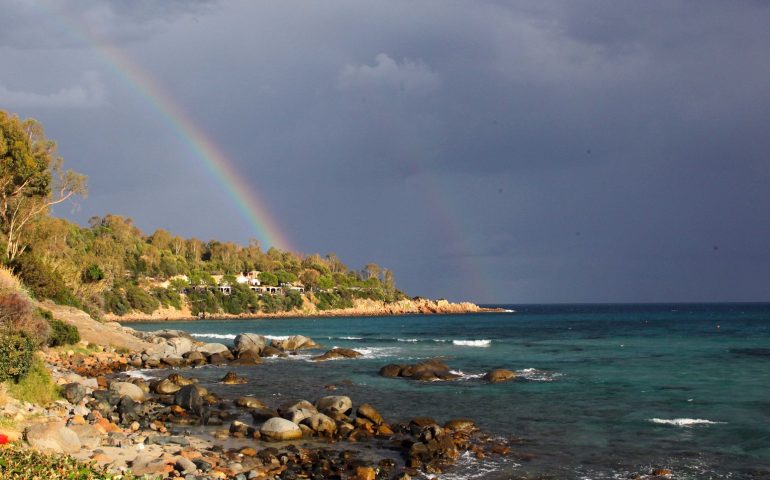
[0, 444, 137, 480]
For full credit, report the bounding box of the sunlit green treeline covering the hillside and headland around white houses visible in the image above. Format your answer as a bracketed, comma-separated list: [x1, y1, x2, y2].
[0, 110, 404, 315]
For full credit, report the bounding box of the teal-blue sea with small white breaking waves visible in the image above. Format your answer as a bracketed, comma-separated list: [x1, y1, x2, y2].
[124, 304, 770, 479]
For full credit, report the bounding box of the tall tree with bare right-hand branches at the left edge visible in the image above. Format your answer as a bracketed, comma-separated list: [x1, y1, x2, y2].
[0, 110, 87, 261]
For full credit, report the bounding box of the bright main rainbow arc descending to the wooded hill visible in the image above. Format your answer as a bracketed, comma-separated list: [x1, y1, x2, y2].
[37, 2, 292, 250]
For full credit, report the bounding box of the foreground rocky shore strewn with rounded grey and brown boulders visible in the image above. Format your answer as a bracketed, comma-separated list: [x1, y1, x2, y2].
[0, 319, 510, 480]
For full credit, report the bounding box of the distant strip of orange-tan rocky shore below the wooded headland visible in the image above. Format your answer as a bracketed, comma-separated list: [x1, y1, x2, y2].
[105, 297, 504, 323]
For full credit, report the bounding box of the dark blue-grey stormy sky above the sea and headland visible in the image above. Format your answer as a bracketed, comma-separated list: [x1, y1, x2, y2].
[0, 0, 770, 303]
